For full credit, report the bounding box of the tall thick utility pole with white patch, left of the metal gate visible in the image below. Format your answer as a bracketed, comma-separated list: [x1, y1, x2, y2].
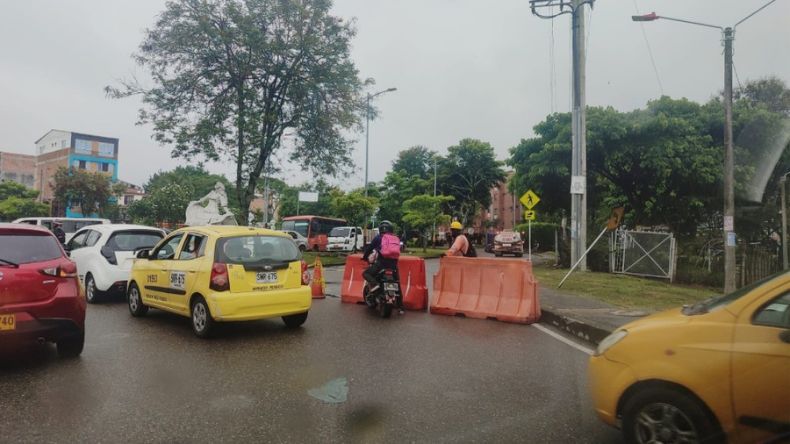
[529, 0, 595, 271]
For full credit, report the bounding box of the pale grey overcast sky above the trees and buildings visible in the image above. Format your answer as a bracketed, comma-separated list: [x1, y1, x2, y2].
[0, 0, 790, 188]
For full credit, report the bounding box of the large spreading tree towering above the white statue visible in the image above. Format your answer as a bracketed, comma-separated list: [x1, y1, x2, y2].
[105, 0, 364, 222]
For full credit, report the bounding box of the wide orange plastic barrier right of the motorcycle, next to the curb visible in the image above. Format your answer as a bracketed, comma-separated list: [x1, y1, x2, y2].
[431, 257, 540, 324]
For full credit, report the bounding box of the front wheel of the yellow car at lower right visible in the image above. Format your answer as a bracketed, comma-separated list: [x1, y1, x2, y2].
[623, 387, 723, 444]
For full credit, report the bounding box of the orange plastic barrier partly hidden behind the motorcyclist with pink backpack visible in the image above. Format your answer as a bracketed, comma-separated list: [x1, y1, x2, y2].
[340, 254, 428, 310]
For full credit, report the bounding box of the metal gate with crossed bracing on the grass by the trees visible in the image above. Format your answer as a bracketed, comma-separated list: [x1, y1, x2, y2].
[609, 230, 677, 281]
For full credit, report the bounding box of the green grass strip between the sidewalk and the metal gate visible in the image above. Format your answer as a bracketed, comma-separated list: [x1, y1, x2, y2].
[533, 267, 719, 310]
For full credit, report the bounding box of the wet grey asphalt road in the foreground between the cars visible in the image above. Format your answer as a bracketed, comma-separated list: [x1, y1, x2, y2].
[0, 258, 620, 443]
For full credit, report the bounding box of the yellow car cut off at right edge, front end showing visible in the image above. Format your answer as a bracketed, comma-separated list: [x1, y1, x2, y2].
[588, 273, 790, 443]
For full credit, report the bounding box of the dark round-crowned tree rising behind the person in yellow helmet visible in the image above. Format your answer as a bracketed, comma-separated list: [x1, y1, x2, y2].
[438, 139, 505, 224]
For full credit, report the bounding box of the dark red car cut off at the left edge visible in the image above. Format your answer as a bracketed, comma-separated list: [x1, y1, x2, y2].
[0, 223, 86, 357]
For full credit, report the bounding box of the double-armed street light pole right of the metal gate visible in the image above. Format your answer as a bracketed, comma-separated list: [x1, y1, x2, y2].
[631, 0, 787, 293]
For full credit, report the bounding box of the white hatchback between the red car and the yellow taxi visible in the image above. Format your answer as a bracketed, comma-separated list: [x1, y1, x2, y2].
[66, 224, 165, 303]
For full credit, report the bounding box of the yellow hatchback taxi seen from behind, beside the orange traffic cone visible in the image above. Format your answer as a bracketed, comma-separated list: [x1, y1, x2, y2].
[126, 225, 312, 337]
